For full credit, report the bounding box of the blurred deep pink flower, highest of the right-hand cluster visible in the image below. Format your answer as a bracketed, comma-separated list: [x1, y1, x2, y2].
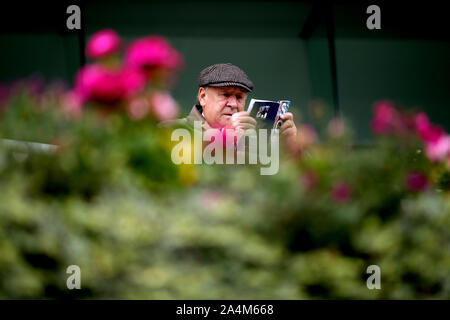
[372, 100, 402, 134]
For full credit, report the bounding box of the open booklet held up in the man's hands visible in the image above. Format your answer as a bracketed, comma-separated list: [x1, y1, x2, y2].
[247, 99, 291, 129]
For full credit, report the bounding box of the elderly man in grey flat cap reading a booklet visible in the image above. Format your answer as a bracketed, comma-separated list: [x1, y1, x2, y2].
[162, 63, 297, 140]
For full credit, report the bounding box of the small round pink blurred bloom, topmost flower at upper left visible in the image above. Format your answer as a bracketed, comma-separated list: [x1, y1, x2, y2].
[86, 29, 121, 59]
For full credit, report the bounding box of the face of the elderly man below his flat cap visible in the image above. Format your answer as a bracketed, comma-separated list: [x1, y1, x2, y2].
[198, 87, 247, 128]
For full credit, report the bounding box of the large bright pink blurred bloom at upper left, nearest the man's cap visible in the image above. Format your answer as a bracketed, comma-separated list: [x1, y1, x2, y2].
[125, 35, 183, 70]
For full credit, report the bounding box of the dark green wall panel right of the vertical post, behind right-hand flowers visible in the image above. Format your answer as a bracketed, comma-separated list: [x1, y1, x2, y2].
[336, 38, 450, 140]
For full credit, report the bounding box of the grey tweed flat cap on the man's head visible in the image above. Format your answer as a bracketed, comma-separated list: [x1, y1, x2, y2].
[198, 63, 253, 92]
